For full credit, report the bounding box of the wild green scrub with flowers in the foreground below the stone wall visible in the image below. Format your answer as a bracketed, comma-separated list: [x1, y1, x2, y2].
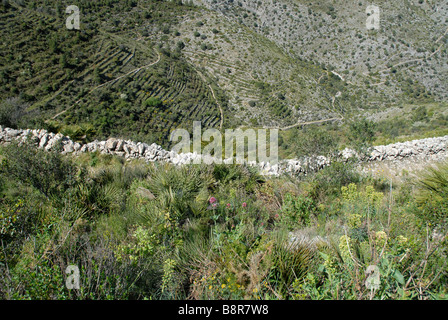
[0, 144, 448, 299]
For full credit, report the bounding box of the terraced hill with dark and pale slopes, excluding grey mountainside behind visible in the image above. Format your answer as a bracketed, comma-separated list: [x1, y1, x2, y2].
[1, 1, 372, 143]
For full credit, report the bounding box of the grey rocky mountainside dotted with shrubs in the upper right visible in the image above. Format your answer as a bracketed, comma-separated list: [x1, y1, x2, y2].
[195, 0, 448, 105]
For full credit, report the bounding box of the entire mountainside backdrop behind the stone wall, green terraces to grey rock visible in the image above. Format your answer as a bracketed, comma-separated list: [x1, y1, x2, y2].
[0, 0, 448, 147]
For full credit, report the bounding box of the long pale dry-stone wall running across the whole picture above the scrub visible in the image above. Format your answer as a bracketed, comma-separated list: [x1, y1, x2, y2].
[0, 126, 448, 175]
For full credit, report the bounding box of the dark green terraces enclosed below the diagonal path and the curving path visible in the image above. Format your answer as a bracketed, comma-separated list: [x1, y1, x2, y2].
[64, 39, 224, 145]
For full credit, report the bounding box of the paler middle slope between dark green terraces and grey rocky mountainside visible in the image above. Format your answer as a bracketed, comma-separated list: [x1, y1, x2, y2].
[140, 2, 354, 127]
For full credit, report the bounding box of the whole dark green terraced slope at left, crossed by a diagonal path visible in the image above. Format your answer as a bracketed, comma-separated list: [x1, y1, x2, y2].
[0, 1, 225, 143]
